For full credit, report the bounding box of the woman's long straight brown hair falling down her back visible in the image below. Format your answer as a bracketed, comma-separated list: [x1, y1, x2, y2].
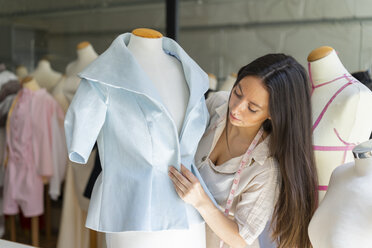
[230, 54, 318, 248]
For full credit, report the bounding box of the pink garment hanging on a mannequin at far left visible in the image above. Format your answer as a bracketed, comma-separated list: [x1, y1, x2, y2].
[3, 88, 66, 217]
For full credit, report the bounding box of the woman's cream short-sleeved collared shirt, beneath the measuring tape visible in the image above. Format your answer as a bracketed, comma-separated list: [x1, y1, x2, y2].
[195, 91, 280, 248]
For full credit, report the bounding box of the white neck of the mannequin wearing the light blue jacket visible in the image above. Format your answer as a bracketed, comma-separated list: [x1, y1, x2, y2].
[127, 34, 164, 56]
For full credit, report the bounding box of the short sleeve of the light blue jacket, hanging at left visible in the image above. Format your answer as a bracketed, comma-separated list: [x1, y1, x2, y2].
[65, 79, 108, 164]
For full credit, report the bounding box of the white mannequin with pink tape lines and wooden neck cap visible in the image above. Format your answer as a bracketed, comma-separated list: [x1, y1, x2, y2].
[308, 47, 372, 202]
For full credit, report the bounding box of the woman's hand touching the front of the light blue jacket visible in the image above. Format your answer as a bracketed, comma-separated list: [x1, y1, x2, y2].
[168, 164, 209, 209]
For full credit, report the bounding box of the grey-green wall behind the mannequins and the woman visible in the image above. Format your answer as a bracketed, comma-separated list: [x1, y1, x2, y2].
[0, 0, 372, 84]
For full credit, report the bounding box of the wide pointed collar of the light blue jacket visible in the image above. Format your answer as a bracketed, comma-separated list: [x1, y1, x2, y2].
[79, 33, 209, 113]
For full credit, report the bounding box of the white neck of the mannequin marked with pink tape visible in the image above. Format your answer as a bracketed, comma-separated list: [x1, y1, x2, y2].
[309, 50, 350, 86]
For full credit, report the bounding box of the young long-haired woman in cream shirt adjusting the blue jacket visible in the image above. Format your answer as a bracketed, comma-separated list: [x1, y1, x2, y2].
[169, 54, 317, 248]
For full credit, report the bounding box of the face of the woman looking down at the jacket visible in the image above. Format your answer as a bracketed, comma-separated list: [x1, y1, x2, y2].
[229, 76, 270, 127]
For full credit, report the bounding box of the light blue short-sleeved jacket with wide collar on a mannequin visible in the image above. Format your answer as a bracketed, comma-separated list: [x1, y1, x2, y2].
[65, 33, 214, 232]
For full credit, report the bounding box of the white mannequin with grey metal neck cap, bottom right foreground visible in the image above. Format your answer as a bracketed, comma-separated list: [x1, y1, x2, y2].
[309, 140, 372, 248]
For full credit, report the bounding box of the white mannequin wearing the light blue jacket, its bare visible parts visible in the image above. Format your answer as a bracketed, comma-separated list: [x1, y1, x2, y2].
[106, 30, 206, 248]
